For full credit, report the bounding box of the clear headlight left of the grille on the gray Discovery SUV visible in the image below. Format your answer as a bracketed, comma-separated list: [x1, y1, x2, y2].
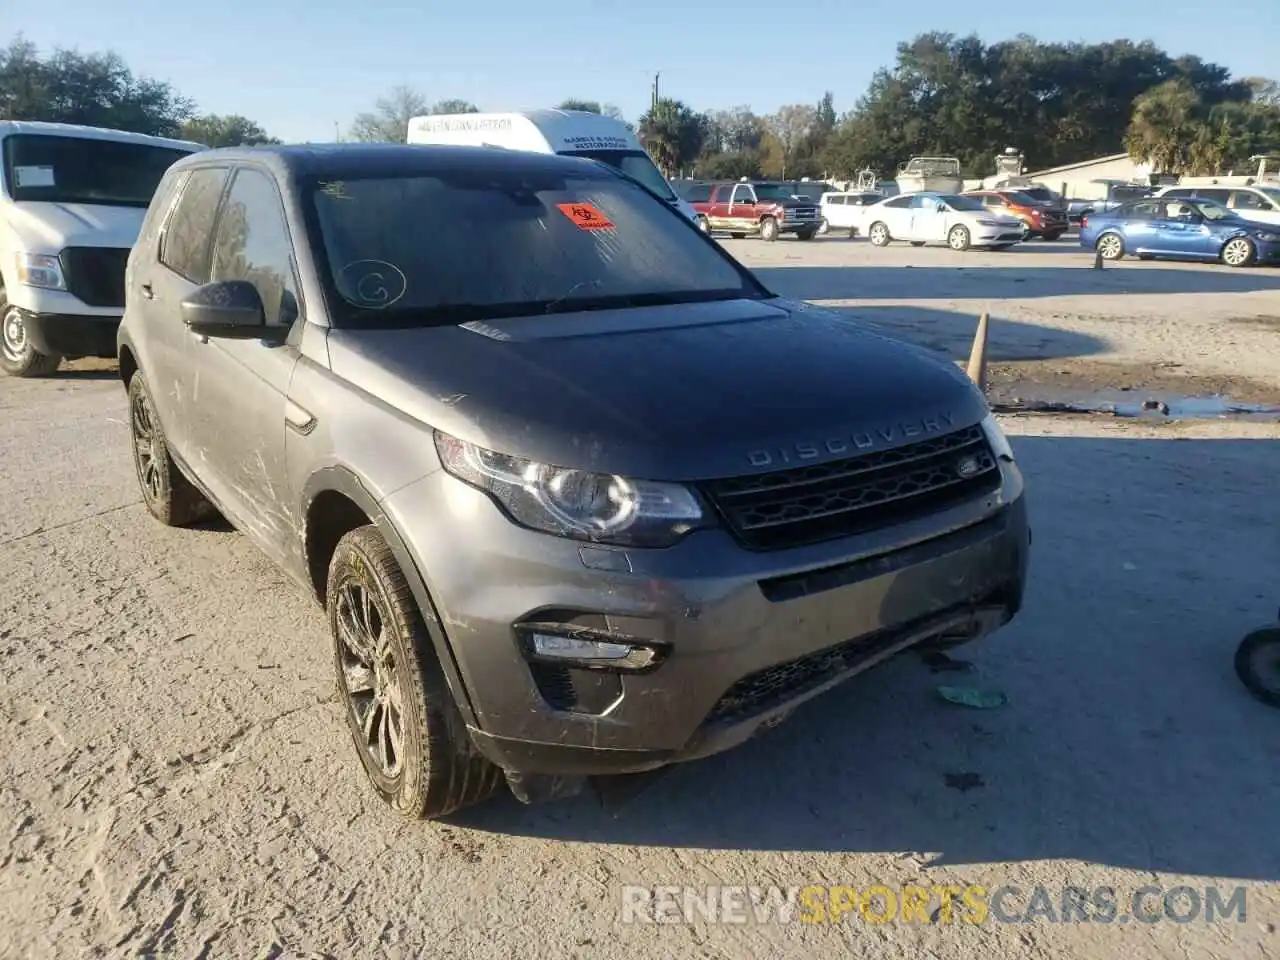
[435, 430, 707, 547]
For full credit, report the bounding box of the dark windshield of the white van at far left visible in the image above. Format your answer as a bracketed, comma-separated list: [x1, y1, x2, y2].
[4, 133, 188, 207]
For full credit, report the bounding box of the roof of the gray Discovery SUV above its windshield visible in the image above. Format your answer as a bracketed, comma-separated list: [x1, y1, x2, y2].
[167, 143, 611, 178]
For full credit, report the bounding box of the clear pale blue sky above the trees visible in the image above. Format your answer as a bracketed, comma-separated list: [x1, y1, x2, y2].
[12, 0, 1280, 140]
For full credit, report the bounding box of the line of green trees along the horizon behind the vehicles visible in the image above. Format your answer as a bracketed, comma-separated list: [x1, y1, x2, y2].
[0, 32, 1280, 179]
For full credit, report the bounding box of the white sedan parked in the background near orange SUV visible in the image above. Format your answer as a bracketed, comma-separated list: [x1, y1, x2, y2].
[860, 193, 1025, 250]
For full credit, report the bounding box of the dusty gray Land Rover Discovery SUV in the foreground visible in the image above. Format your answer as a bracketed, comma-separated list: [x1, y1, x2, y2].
[119, 145, 1029, 818]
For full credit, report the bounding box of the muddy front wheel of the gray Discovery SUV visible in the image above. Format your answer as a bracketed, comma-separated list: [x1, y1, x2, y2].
[325, 524, 503, 820]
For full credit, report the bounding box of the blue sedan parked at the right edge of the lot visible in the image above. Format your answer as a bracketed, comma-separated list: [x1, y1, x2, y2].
[1080, 197, 1280, 266]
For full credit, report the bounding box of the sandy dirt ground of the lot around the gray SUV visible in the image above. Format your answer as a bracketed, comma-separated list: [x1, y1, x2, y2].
[0, 239, 1280, 960]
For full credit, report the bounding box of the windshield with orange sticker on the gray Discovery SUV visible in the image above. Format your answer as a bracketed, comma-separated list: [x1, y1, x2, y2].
[303, 170, 769, 328]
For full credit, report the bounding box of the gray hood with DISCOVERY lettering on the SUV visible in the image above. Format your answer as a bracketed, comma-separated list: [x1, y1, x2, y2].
[329, 298, 987, 480]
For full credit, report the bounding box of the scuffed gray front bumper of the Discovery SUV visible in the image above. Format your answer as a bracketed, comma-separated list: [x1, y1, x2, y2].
[383, 463, 1029, 776]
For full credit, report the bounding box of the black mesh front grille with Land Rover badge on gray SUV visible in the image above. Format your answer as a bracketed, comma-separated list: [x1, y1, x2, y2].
[703, 426, 1000, 550]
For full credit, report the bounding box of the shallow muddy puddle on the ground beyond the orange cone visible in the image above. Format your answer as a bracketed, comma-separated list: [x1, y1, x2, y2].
[992, 389, 1280, 422]
